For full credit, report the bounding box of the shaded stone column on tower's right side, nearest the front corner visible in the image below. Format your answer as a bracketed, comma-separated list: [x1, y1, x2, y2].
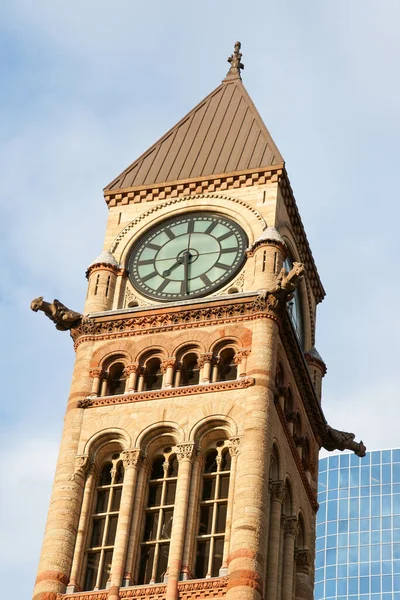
[266, 481, 285, 600]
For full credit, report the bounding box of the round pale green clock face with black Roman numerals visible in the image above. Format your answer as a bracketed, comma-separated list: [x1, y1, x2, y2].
[129, 212, 247, 301]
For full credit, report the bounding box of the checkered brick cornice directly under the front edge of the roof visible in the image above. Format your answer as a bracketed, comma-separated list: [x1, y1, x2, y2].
[104, 163, 284, 207]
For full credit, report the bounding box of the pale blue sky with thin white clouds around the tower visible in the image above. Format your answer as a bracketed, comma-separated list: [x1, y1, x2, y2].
[0, 0, 400, 599]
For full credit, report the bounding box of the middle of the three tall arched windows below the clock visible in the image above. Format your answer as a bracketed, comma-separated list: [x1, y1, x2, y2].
[138, 448, 178, 584]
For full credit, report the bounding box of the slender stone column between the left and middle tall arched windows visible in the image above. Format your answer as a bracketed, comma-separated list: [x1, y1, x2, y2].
[108, 448, 141, 600]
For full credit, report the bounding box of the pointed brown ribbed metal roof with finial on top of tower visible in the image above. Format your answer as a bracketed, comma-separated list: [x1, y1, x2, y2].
[105, 42, 283, 190]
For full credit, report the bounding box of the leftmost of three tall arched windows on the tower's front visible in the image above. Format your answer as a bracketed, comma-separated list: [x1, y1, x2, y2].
[83, 454, 124, 591]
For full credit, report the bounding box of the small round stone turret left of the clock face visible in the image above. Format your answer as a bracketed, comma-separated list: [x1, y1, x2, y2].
[85, 250, 123, 313]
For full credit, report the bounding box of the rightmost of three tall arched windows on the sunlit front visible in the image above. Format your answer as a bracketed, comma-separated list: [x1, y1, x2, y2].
[195, 441, 231, 579]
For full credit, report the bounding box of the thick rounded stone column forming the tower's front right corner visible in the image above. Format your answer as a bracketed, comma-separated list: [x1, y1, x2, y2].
[226, 316, 279, 600]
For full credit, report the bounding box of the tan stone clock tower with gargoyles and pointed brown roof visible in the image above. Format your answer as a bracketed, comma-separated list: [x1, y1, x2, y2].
[31, 42, 365, 600]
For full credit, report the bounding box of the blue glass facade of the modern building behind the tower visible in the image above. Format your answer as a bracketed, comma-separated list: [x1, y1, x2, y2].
[315, 449, 400, 600]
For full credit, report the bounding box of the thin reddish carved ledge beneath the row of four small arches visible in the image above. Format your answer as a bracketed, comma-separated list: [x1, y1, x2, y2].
[78, 377, 255, 408]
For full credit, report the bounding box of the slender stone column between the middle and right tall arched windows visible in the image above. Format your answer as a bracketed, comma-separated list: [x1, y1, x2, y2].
[166, 442, 194, 600]
